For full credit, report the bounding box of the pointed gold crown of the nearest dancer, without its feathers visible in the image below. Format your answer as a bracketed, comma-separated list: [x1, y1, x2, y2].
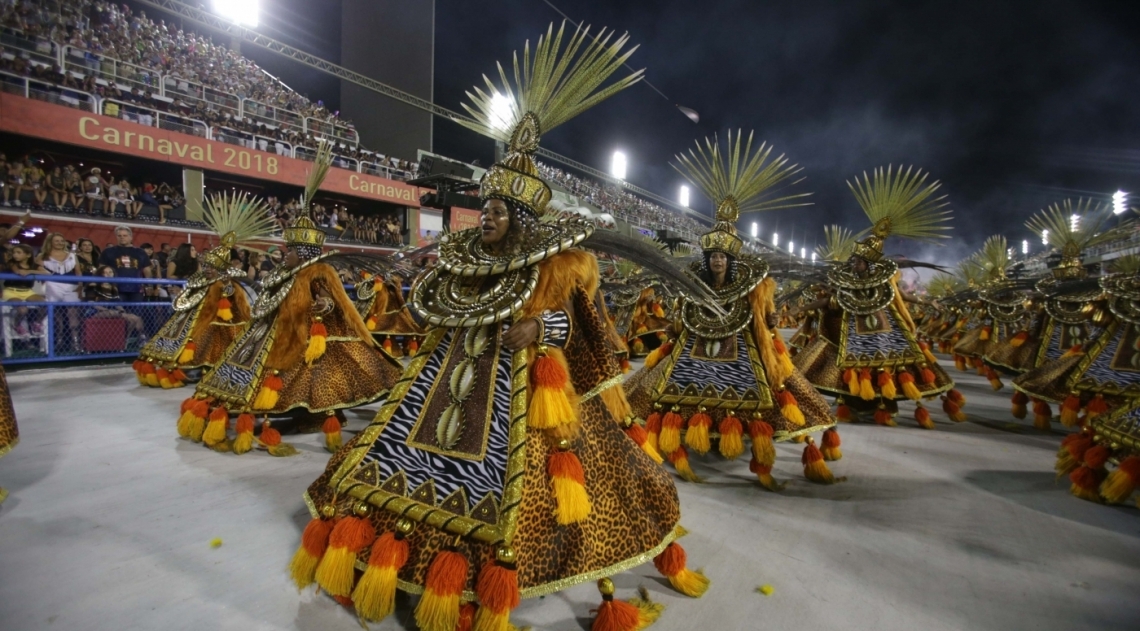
[479, 112, 552, 216]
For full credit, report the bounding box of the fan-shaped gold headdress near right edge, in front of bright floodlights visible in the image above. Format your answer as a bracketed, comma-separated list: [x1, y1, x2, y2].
[1025, 198, 1131, 279]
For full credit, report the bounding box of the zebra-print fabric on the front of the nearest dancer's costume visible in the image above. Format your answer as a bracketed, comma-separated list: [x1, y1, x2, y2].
[361, 329, 511, 508]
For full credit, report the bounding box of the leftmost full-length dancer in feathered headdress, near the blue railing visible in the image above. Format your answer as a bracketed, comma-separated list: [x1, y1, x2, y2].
[135, 194, 275, 388]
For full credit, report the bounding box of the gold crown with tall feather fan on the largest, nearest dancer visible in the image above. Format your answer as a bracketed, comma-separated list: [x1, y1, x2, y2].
[458, 22, 644, 216]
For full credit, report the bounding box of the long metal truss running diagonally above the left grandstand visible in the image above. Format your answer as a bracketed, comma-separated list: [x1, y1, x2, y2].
[131, 0, 711, 223]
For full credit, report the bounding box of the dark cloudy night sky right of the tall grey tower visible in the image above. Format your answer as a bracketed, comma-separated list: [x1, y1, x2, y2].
[435, 0, 1140, 262]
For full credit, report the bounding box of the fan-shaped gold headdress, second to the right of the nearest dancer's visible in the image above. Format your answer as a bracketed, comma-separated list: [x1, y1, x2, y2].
[847, 166, 950, 263]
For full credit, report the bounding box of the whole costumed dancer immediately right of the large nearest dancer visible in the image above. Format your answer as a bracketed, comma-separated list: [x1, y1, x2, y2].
[626, 132, 838, 491]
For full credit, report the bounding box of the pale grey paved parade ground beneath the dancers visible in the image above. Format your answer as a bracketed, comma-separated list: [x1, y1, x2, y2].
[0, 357, 1140, 631]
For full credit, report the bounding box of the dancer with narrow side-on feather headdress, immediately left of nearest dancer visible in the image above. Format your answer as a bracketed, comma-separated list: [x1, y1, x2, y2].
[178, 144, 401, 456]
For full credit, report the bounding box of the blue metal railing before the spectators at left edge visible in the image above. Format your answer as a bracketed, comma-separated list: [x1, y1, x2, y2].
[0, 273, 186, 364]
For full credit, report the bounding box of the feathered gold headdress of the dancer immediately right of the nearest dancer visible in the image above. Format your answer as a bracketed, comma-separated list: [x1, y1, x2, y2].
[673, 130, 811, 256]
